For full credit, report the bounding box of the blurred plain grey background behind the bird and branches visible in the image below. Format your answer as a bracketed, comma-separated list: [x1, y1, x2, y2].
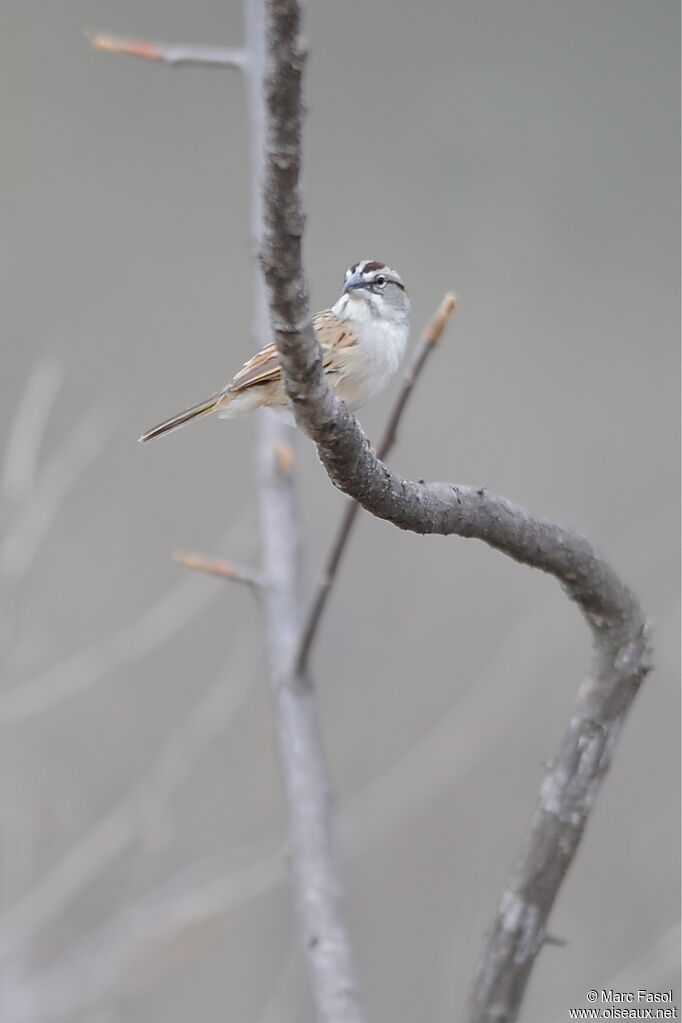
[0, 0, 680, 1023]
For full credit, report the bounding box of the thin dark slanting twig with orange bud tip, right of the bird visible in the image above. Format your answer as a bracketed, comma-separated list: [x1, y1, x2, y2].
[295, 295, 457, 675]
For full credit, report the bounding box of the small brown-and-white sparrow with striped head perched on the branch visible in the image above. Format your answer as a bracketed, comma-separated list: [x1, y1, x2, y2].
[139, 260, 410, 443]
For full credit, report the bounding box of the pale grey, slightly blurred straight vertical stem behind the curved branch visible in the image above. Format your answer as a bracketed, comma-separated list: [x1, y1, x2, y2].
[244, 0, 363, 1023]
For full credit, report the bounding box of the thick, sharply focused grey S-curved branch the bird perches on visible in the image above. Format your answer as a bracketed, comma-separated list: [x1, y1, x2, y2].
[258, 0, 651, 1023]
